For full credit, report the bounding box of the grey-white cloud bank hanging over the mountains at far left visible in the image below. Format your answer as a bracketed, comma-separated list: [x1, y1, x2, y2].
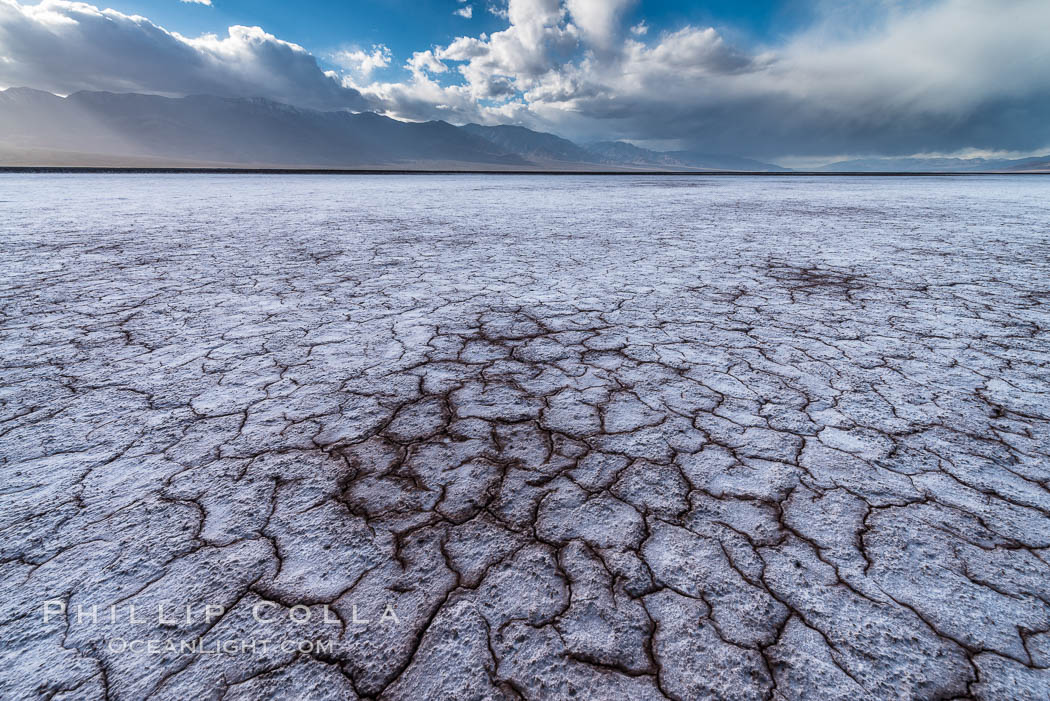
[0, 0, 366, 109]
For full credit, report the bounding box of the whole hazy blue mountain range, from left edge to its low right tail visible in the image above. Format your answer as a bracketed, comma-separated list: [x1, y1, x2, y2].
[0, 88, 783, 171]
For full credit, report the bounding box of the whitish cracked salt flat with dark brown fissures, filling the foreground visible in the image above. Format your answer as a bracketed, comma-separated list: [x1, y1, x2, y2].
[0, 175, 1050, 700]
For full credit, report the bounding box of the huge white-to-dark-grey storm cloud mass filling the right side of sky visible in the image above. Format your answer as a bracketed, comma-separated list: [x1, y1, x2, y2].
[364, 0, 1050, 157]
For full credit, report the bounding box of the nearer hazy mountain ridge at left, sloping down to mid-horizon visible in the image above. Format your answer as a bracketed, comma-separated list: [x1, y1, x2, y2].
[0, 89, 527, 167]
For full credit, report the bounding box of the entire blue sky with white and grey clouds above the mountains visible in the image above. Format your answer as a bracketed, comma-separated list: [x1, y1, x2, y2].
[0, 0, 1050, 163]
